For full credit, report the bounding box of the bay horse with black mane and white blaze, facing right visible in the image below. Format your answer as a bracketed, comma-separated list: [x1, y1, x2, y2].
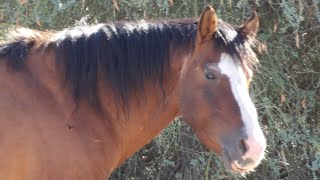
[0, 6, 266, 180]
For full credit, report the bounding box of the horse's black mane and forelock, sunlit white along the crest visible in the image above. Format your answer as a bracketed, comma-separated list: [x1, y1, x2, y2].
[0, 19, 255, 109]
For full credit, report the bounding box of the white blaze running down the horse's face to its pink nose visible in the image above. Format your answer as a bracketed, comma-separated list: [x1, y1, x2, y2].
[218, 53, 266, 163]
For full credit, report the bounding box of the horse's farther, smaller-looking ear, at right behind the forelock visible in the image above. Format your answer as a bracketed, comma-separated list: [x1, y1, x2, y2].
[239, 11, 259, 37]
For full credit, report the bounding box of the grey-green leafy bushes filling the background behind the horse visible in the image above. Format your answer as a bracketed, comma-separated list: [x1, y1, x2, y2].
[0, 0, 320, 180]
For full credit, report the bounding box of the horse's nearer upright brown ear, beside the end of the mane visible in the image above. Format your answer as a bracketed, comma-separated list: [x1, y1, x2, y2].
[197, 5, 218, 42]
